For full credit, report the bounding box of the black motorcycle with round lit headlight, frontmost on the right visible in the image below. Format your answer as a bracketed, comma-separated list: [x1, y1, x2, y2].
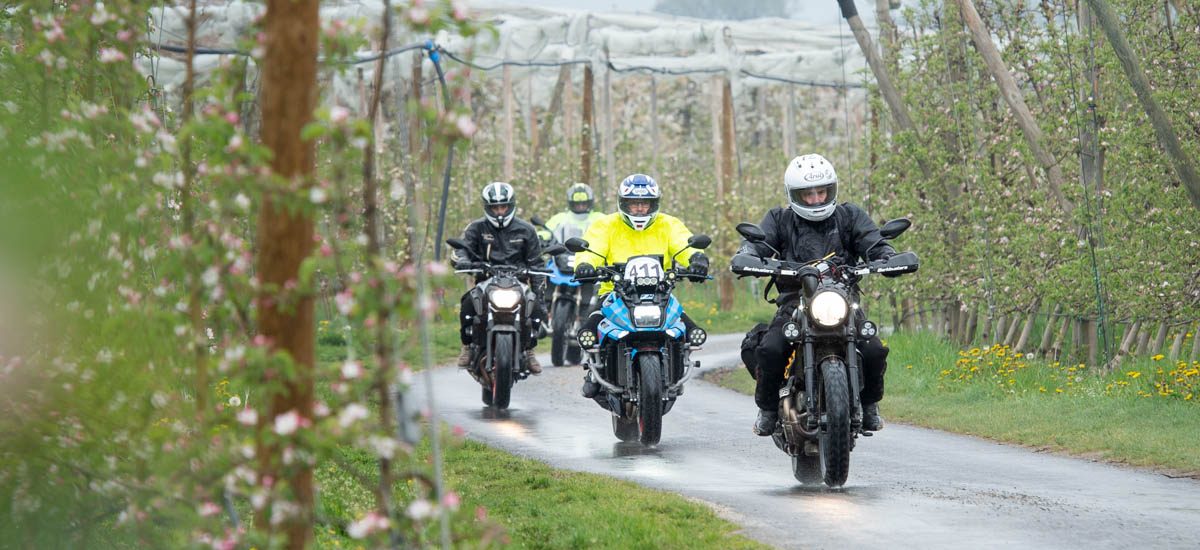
[731, 219, 919, 488]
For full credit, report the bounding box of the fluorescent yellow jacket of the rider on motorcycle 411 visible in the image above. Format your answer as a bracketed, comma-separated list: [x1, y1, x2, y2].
[575, 213, 691, 294]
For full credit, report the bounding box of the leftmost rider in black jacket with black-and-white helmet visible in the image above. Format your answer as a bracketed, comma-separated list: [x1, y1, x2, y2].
[452, 181, 546, 375]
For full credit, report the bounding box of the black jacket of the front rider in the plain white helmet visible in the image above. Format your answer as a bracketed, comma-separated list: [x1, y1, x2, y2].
[738, 203, 895, 294]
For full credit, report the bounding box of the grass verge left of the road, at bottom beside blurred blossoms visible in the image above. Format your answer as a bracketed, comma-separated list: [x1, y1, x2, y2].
[316, 440, 770, 549]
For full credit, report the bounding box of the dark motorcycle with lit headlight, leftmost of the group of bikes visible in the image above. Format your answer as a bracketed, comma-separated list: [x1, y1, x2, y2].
[446, 239, 566, 409]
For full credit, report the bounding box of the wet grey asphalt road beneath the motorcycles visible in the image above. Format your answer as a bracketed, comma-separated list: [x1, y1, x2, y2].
[414, 335, 1200, 549]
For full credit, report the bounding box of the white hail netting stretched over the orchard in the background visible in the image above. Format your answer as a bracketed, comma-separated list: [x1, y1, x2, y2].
[138, 1, 868, 110]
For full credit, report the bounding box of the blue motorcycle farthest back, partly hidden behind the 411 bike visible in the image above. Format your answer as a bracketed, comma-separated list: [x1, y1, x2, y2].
[530, 216, 595, 366]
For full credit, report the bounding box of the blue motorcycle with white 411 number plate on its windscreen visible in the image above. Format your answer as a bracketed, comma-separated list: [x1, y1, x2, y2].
[566, 235, 712, 446]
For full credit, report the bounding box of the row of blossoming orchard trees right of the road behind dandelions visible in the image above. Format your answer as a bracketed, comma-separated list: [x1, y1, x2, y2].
[849, 0, 1200, 365]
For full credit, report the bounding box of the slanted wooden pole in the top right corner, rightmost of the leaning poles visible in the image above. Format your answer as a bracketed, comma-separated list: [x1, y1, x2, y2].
[1087, 0, 1200, 208]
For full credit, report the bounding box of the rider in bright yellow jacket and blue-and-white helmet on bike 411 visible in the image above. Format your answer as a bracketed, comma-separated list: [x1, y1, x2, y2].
[575, 174, 708, 397]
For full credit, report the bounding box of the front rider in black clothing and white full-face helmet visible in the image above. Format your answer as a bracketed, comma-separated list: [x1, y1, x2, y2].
[739, 154, 895, 436]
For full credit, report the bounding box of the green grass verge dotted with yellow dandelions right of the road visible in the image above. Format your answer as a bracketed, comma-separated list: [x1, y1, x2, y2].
[709, 333, 1200, 476]
